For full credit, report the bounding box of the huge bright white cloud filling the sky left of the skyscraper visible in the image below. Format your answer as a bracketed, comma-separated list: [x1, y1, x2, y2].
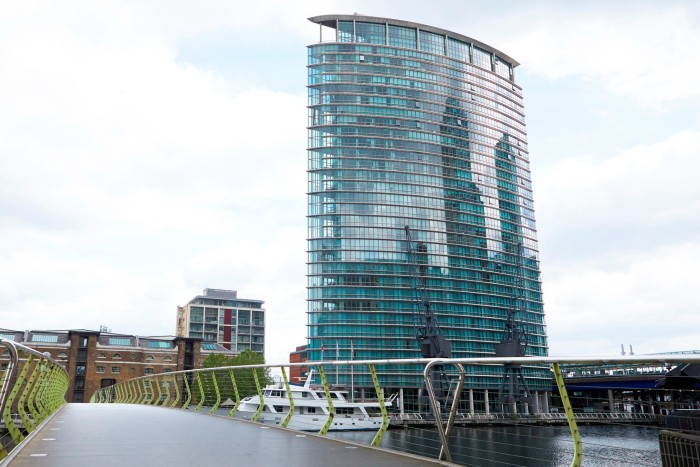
[0, 2, 306, 362]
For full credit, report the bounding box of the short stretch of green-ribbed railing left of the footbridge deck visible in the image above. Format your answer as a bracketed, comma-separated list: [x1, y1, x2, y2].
[0, 338, 69, 460]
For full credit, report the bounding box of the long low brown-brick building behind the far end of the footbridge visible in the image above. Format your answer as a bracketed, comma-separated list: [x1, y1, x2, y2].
[0, 329, 231, 402]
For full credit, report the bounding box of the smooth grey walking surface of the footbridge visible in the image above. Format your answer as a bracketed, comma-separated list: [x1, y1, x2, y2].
[9, 404, 445, 467]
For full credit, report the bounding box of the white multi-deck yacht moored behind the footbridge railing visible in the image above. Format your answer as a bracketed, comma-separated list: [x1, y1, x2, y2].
[238, 370, 397, 431]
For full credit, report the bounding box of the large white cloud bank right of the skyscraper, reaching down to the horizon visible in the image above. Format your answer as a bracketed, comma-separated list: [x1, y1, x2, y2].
[535, 132, 700, 354]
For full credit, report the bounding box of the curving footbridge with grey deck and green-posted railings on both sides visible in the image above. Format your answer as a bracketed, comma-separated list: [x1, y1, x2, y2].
[0, 339, 700, 466]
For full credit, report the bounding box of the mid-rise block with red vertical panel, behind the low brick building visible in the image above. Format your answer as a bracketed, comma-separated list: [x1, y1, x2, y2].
[177, 289, 265, 355]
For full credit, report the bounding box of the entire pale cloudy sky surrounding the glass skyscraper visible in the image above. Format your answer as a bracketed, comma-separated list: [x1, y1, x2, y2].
[0, 0, 700, 363]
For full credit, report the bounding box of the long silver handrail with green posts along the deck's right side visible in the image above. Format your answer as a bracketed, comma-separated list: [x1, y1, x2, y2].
[91, 355, 700, 466]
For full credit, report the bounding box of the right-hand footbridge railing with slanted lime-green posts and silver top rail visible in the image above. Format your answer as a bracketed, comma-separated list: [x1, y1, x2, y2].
[91, 355, 700, 467]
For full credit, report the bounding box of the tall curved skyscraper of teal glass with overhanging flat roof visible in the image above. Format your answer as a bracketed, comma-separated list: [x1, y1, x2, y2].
[308, 15, 551, 390]
